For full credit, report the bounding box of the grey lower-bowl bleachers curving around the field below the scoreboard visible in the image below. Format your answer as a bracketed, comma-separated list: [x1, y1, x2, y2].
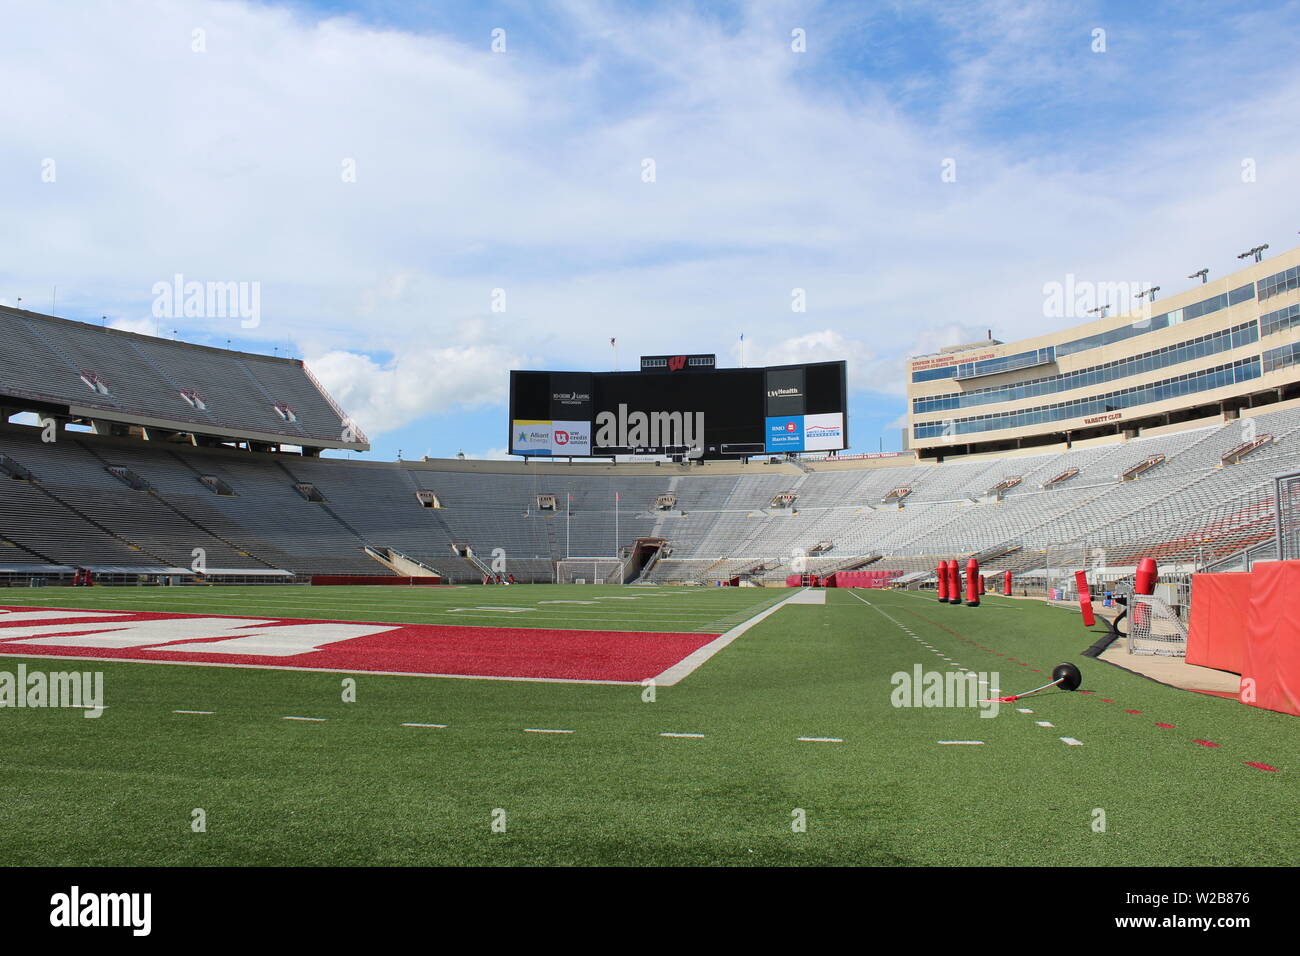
[0, 395, 1300, 583]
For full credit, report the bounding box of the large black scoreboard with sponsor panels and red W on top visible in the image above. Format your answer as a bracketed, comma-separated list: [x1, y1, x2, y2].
[508, 355, 849, 459]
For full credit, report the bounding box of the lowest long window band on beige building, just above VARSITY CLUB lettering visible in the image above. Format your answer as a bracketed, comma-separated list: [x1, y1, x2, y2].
[913, 350, 1258, 440]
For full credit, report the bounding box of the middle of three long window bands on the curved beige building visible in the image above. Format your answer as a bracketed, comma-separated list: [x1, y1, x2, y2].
[911, 323, 1258, 415]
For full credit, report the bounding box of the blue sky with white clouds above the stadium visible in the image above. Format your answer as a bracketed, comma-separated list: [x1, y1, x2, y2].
[0, 0, 1300, 458]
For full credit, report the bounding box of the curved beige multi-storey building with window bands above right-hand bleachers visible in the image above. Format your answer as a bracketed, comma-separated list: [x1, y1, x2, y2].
[907, 248, 1300, 459]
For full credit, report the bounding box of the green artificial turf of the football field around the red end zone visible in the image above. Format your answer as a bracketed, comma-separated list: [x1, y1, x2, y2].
[0, 585, 1300, 865]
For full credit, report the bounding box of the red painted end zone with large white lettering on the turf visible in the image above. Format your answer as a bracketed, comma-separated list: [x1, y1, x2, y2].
[0, 606, 718, 683]
